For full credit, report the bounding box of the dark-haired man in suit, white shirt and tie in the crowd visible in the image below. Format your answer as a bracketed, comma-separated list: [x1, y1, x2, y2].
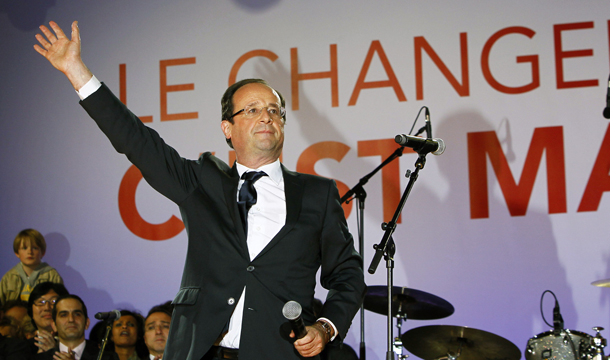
[35, 295, 117, 360]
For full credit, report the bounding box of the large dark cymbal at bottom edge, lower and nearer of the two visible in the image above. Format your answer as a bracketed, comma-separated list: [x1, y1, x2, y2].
[401, 325, 521, 360]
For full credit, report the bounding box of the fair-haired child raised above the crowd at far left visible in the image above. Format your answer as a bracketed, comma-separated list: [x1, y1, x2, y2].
[0, 229, 64, 304]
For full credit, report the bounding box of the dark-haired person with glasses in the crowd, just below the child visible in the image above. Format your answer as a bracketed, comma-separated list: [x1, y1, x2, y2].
[28, 282, 68, 353]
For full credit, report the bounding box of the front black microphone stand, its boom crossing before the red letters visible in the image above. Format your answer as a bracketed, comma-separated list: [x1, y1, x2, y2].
[368, 154, 426, 360]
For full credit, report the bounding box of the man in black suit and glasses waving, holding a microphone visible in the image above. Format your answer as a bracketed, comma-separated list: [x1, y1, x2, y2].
[35, 22, 365, 360]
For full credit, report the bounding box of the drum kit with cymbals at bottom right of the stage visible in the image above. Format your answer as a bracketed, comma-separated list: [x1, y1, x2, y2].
[364, 279, 610, 360]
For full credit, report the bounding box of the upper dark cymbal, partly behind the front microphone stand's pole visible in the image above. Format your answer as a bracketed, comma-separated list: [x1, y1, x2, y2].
[364, 286, 455, 320]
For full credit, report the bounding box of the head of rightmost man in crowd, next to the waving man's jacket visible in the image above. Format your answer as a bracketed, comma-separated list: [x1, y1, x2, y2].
[144, 301, 173, 360]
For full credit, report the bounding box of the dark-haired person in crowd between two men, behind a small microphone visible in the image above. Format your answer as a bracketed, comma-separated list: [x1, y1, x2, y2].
[110, 310, 146, 360]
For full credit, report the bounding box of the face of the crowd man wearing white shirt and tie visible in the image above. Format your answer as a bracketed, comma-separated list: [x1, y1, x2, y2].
[53, 298, 89, 343]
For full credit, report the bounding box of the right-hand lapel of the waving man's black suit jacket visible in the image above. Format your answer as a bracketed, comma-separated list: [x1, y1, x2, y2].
[256, 165, 304, 258]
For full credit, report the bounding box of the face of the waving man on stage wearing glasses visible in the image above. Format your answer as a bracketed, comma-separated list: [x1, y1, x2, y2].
[221, 83, 284, 160]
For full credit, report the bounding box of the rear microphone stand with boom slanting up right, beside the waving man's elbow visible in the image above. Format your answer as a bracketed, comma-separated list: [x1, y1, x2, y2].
[341, 146, 405, 360]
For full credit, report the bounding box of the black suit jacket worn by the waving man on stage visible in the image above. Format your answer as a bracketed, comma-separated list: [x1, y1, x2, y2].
[81, 85, 365, 360]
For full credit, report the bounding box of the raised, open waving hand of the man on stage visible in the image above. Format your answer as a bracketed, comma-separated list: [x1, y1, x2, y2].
[34, 21, 93, 90]
